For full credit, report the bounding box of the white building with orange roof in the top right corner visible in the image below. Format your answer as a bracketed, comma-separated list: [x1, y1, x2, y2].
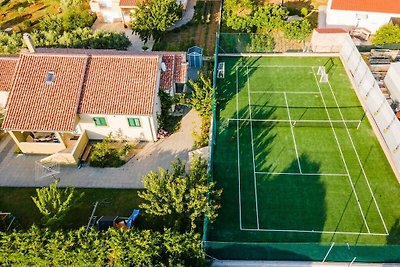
[326, 0, 400, 33]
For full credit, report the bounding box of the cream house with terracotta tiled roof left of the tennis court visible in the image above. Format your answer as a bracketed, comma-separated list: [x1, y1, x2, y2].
[0, 49, 187, 164]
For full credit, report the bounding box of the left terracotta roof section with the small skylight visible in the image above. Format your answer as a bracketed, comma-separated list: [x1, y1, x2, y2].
[3, 54, 86, 131]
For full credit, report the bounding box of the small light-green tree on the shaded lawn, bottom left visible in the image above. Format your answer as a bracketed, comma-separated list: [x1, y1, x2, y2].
[32, 180, 83, 226]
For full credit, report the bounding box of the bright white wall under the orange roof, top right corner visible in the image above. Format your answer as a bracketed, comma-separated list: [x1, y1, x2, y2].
[326, 9, 400, 33]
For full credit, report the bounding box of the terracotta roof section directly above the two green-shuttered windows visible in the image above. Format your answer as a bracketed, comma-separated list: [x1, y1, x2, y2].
[78, 55, 160, 115]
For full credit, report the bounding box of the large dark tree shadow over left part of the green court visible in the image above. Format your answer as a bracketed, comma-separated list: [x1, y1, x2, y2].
[208, 90, 326, 247]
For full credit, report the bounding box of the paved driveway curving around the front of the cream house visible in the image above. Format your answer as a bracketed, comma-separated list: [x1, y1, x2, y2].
[0, 111, 200, 188]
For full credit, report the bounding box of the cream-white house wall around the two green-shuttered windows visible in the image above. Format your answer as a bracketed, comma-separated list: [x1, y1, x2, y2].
[79, 114, 157, 141]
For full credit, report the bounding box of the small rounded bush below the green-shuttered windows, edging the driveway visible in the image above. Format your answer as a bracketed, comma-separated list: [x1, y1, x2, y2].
[89, 137, 125, 168]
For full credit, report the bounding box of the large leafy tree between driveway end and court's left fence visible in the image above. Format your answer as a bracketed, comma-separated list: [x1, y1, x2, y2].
[138, 158, 222, 231]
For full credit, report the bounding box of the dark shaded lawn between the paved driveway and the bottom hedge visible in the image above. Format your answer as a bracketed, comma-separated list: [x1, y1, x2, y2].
[0, 187, 162, 230]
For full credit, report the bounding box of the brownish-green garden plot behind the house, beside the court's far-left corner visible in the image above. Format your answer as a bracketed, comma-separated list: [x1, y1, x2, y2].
[153, 1, 220, 55]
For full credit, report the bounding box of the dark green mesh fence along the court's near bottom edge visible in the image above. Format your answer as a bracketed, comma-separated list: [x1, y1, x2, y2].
[204, 241, 400, 263]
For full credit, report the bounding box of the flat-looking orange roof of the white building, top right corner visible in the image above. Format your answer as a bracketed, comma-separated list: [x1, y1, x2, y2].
[331, 0, 400, 14]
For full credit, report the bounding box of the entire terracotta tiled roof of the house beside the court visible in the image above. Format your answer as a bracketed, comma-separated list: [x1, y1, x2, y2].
[3, 49, 187, 131]
